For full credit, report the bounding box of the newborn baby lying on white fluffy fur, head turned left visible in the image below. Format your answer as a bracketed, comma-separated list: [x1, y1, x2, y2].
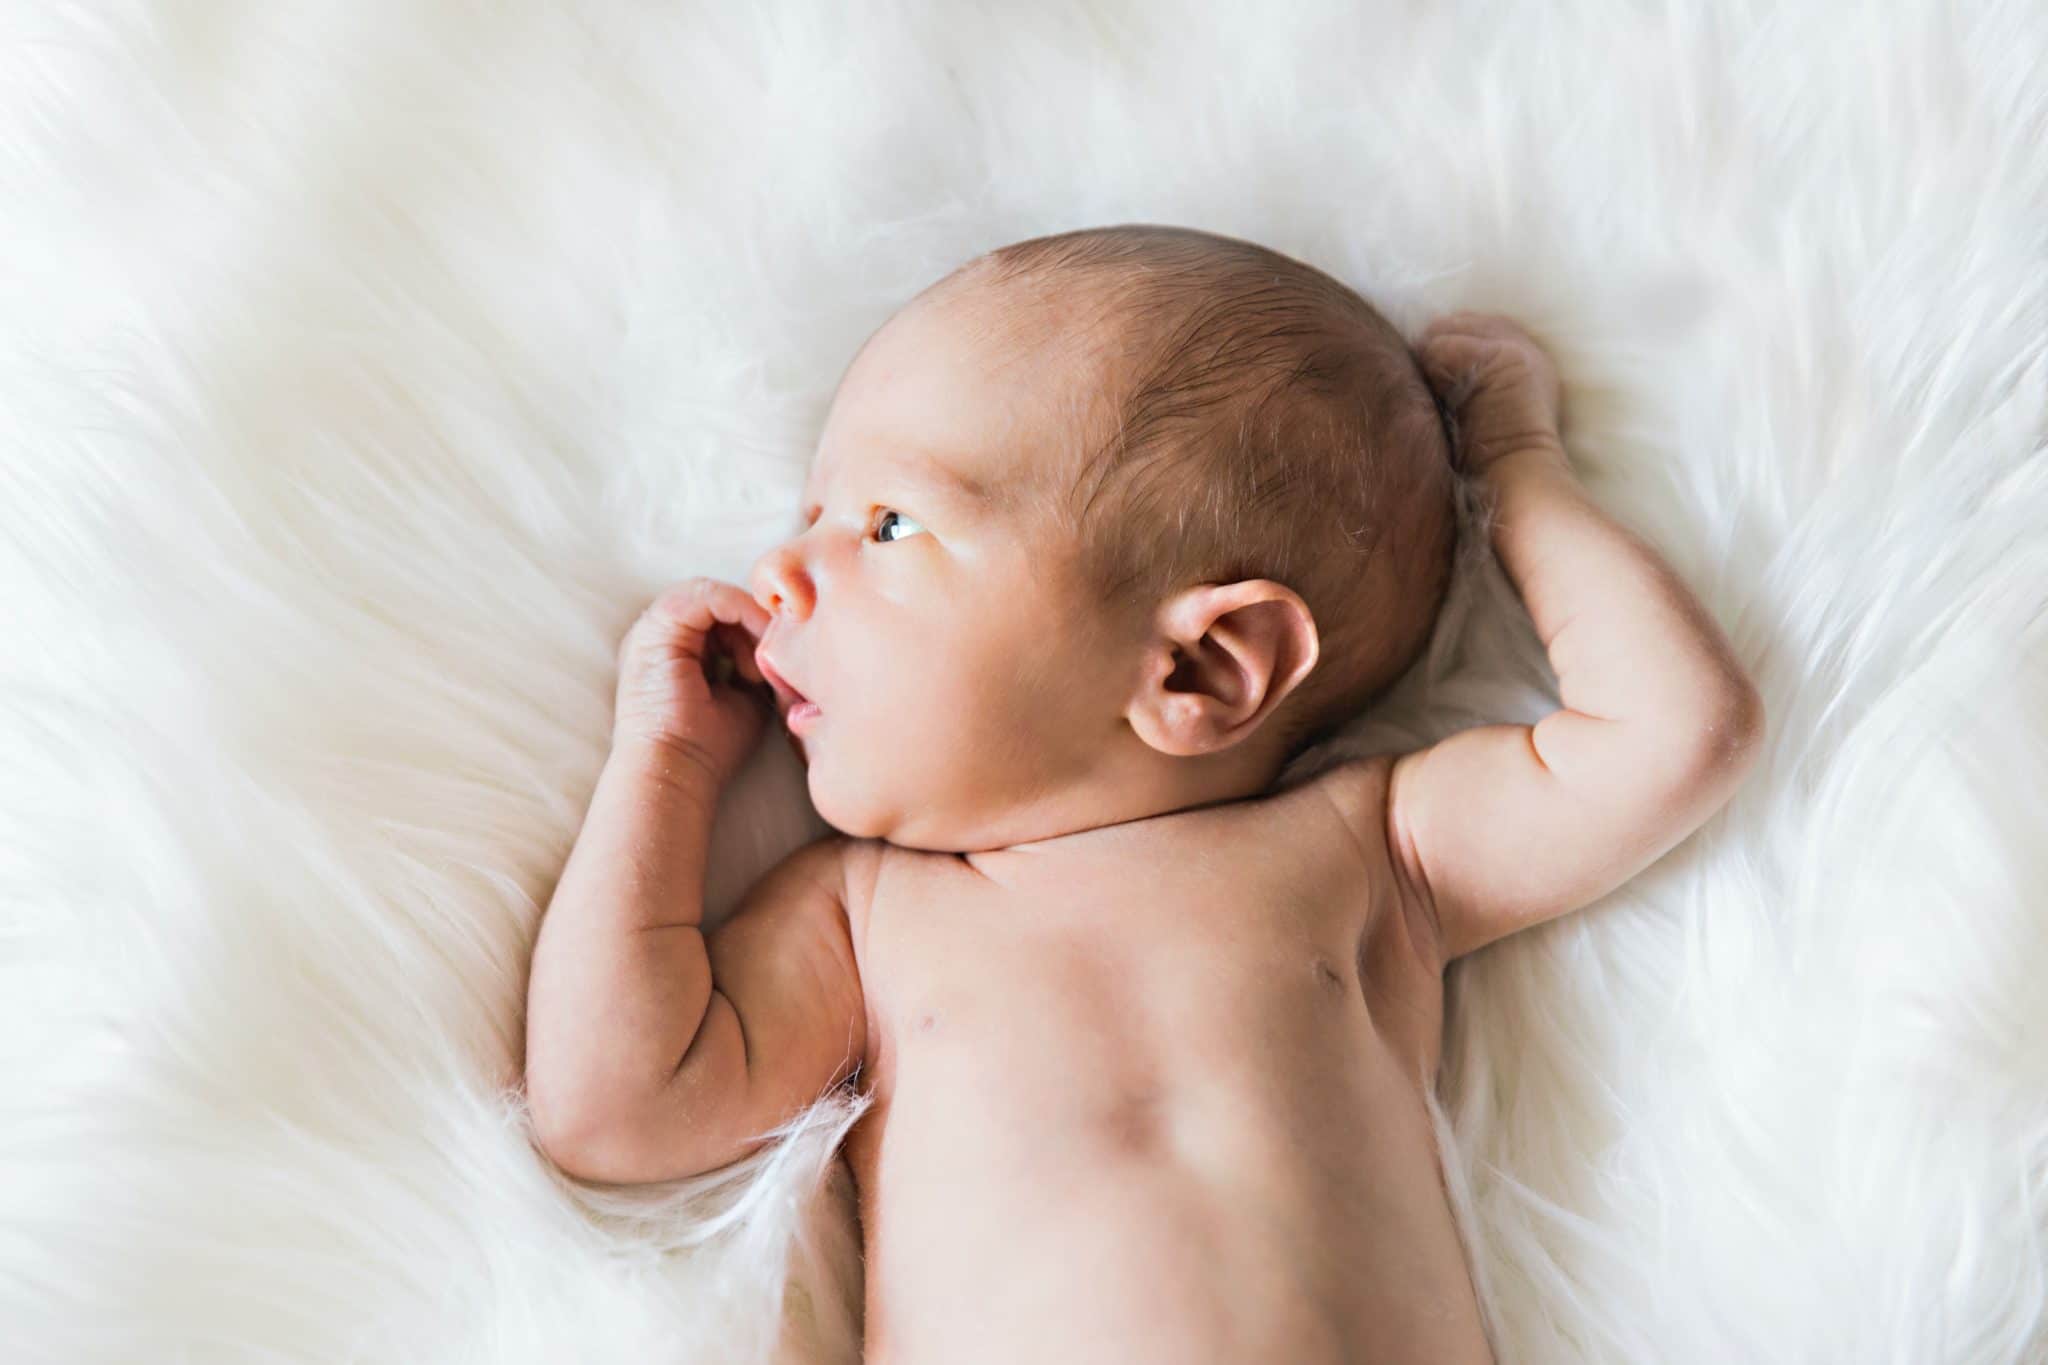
[526, 225, 1763, 1365]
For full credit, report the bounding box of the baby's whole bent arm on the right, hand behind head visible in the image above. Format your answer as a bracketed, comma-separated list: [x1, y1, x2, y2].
[1386, 313, 1763, 960]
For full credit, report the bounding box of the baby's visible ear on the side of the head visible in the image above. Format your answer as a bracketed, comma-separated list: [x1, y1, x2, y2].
[1124, 579, 1321, 757]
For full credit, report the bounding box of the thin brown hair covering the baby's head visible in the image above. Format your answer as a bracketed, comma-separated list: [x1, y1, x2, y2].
[946, 223, 1456, 757]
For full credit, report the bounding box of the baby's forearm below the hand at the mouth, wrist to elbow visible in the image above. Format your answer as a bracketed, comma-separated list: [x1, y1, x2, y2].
[526, 743, 719, 1140]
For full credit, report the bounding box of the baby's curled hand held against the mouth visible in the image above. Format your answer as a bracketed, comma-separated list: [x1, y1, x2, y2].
[612, 577, 774, 786]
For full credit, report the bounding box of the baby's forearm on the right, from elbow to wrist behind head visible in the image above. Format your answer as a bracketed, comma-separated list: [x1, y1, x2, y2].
[1487, 446, 1757, 780]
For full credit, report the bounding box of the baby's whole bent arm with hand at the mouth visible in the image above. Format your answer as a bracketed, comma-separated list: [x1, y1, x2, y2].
[526, 579, 866, 1183]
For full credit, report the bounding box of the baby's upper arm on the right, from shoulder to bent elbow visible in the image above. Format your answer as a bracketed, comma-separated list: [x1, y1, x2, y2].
[1384, 684, 1761, 960]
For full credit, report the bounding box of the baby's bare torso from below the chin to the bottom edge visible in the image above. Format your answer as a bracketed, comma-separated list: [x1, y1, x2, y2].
[846, 759, 1489, 1363]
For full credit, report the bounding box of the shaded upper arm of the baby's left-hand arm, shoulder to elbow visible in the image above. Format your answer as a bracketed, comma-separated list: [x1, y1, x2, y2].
[586, 837, 866, 1183]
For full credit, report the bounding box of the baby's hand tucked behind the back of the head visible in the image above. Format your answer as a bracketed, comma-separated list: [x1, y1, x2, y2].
[1415, 313, 1571, 475]
